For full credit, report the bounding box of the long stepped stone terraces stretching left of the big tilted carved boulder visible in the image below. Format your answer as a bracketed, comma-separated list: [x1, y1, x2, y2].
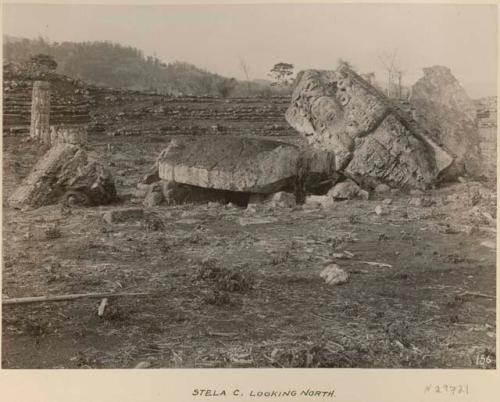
[3, 59, 297, 141]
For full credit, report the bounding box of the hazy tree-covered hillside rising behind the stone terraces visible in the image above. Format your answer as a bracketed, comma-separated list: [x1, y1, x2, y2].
[3, 37, 287, 98]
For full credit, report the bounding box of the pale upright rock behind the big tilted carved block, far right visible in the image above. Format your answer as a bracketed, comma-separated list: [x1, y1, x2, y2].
[410, 66, 481, 179]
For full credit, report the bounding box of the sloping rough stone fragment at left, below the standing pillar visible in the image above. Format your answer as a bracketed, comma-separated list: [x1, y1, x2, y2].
[8, 144, 116, 208]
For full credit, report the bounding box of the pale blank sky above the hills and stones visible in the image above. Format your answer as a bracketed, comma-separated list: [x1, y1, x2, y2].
[3, 4, 497, 97]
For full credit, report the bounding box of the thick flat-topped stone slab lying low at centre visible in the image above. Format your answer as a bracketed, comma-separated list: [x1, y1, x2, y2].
[158, 136, 301, 193]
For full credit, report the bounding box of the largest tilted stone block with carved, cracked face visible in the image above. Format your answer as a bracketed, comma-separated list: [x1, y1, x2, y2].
[285, 66, 452, 188]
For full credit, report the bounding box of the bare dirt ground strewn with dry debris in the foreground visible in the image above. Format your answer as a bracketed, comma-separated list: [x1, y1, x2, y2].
[2, 98, 496, 368]
